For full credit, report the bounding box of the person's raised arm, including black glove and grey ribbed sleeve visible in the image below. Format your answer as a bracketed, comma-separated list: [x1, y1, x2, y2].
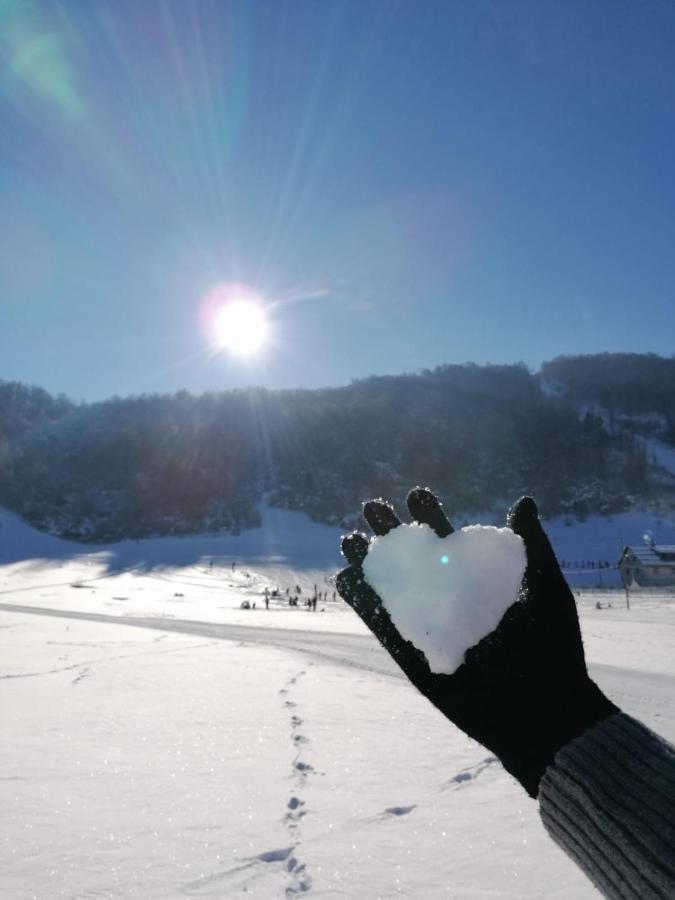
[337, 488, 675, 900]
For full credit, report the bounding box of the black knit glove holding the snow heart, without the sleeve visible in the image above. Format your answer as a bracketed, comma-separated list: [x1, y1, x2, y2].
[337, 488, 618, 797]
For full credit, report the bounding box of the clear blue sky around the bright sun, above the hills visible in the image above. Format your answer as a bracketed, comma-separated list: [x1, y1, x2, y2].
[0, 0, 675, 399]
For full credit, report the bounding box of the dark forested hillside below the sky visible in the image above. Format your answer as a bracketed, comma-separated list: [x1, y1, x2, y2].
[0, 354, 675, 542]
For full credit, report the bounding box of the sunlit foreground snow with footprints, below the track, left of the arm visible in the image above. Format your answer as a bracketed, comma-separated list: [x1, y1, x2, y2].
[0, 612, 596, 900]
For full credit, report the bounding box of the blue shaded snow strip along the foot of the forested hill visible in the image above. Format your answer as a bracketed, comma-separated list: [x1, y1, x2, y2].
[0, 496, 675, 591]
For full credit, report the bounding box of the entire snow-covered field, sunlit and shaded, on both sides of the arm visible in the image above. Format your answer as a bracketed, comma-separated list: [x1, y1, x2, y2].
[0, 513, 675, 900]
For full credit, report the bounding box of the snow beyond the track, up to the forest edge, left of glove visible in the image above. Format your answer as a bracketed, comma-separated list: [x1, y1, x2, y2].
[0, 508, 366, 633]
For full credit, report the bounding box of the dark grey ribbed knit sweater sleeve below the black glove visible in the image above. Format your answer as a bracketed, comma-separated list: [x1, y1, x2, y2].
[539, 713, 675, 900]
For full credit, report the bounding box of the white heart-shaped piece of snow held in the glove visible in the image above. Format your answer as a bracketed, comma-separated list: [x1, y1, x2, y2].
[363, 525, 526, 675]
